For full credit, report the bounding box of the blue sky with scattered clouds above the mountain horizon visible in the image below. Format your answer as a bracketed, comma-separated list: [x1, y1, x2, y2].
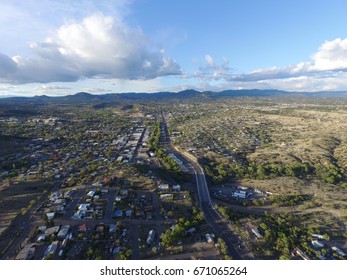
[0, 0, 347, 96]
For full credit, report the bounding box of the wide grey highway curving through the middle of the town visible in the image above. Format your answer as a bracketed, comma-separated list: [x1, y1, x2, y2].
[160, 113, 252, 260]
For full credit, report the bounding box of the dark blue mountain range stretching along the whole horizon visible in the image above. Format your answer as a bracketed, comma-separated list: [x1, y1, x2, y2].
[0, 89, 347, 105]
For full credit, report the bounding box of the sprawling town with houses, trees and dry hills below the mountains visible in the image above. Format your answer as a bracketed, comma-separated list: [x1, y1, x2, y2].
[0, 94, 347, 260]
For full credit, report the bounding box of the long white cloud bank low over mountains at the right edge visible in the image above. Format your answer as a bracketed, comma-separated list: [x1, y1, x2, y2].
[181, 38, 347, 91]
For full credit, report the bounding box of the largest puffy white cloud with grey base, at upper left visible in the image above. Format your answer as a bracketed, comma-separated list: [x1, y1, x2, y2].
[0, 13, 181, 83]
